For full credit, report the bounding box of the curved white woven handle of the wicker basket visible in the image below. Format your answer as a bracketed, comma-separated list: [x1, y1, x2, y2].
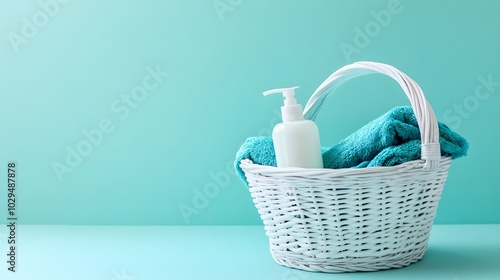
[304, 61, 441, 170]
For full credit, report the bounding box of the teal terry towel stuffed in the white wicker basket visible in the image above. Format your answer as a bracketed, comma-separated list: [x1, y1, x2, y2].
[235, 106, 469, 185]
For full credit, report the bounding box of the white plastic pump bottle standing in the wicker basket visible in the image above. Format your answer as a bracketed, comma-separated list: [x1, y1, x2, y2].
[264, 87, 323, 168]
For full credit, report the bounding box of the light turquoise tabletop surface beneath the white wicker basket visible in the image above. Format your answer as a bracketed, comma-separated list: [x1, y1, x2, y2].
[0, 225, 500, 280]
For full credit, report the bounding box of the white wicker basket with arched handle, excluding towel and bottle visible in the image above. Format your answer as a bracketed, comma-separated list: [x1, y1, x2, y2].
[240, 62, 451, 272]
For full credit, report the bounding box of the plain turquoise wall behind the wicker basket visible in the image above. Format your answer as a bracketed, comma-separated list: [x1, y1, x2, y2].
[0, 0, 500, 225]
